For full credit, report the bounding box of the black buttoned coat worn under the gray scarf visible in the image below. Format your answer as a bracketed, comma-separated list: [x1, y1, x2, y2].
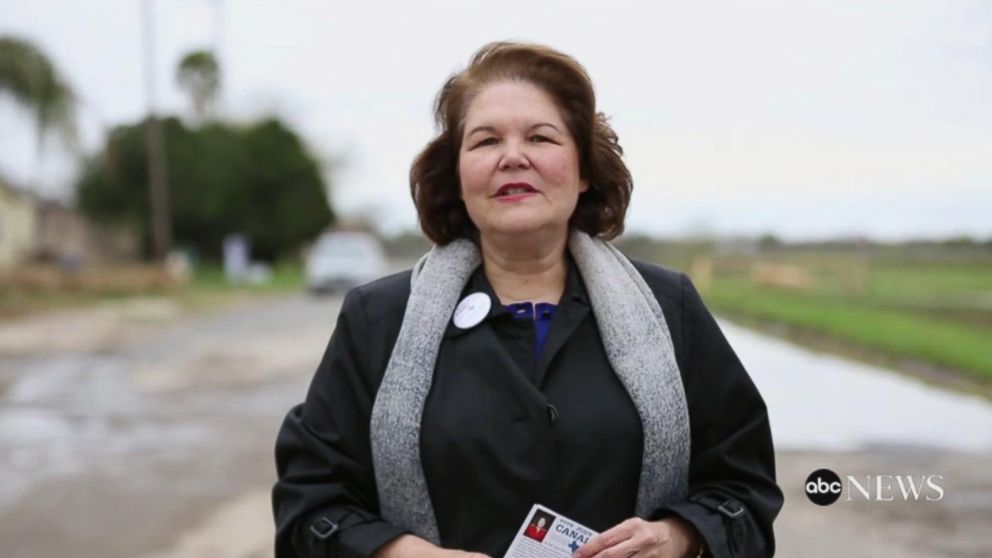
[273, 261, 782, 558]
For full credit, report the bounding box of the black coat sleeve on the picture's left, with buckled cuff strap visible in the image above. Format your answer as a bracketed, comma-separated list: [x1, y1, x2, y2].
[272, 289, 405, 558]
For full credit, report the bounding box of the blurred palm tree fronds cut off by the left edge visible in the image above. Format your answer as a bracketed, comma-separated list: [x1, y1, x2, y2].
[0, 37, 78, 159]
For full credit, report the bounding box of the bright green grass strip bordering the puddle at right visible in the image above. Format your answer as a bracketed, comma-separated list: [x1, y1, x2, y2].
[704, 262, 992, 381]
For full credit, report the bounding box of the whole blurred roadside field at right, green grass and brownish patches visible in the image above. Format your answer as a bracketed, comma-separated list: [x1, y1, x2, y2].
[629, 238, 992, 387]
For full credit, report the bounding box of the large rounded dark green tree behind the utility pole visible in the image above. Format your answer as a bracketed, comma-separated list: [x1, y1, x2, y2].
[78, 118, 334, 260]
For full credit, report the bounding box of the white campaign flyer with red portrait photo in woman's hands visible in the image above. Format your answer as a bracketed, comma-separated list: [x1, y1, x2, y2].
[504, 504, 597, 558]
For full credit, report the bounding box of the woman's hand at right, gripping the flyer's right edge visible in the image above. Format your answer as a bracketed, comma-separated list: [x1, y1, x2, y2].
[572, 517, 703, 558]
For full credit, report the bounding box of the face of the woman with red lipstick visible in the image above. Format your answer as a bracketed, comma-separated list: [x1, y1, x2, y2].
[458, 81, 588, 241]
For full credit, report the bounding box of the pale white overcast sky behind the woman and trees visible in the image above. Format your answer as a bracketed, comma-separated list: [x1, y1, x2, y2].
[0, 0, 992, 239]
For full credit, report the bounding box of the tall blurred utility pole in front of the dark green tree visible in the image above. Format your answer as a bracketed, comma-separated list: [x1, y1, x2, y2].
[141, 0, 172, 261]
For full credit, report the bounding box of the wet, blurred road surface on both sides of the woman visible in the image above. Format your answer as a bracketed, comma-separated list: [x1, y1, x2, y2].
[0, 295, 992, 558]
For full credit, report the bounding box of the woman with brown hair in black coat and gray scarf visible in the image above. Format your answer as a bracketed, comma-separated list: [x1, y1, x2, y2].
[273, 43, 782, 558]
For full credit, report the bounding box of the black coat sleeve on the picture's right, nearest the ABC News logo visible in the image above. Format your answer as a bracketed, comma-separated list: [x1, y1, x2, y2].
[655, 274, 783, 558]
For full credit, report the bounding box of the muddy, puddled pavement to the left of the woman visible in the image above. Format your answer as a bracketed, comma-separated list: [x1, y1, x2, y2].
[0, 296, 340, 558]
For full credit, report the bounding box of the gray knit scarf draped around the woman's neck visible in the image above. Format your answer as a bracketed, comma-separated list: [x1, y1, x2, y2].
[370, 231, 689, 544]
